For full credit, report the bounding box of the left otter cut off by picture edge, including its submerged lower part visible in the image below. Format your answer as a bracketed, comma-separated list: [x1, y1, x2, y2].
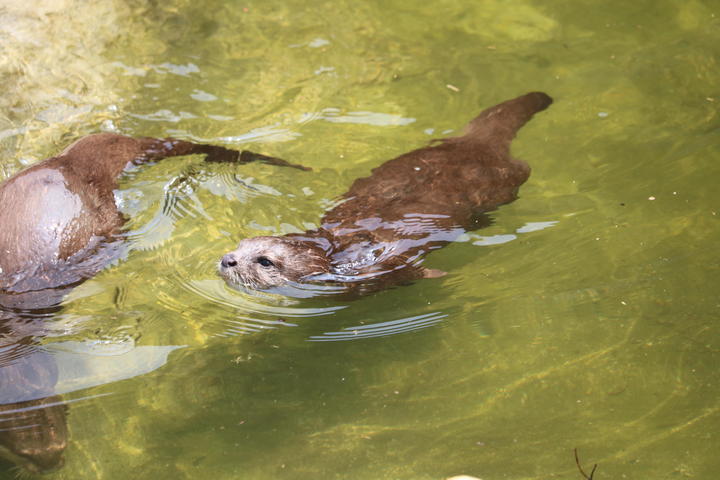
[0, 133, 307, 472]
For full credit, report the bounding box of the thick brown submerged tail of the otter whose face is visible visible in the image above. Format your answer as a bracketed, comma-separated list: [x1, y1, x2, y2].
[458, 92, 553, 147]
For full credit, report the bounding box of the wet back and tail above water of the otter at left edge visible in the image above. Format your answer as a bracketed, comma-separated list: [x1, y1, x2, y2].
[0, 133, 304, 300]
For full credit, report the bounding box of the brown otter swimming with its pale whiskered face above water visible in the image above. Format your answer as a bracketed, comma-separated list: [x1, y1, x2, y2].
[218, 92, 552, 293]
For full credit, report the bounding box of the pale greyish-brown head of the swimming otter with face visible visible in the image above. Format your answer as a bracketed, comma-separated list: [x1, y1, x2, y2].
[218, 237, 330, 289]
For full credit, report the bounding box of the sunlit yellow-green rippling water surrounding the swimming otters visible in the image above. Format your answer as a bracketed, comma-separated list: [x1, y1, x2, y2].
[0, 0, 720, 480]
